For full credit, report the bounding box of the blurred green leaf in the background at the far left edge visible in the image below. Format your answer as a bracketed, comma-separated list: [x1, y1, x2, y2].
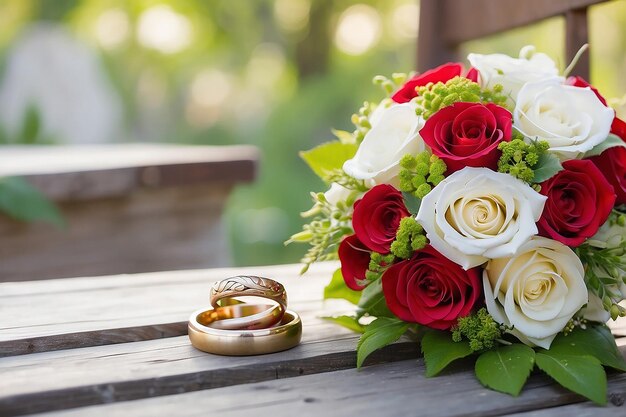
[0, 177, 65, 227]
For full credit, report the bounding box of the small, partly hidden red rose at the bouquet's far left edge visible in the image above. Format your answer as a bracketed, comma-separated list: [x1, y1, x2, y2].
[338, 235, 370, 291]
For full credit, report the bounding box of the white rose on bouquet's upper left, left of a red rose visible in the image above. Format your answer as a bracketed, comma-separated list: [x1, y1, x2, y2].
[343, 103, 424, 187]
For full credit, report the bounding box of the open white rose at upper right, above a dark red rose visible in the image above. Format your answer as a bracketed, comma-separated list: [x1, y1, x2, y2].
[513, 80, 615, 160]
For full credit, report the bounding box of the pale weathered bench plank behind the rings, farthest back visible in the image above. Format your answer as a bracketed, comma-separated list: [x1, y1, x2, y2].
[0, 262, 342, 357]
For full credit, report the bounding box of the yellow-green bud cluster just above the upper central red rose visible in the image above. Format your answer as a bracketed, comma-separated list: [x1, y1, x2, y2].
[416, 77, 506, 120]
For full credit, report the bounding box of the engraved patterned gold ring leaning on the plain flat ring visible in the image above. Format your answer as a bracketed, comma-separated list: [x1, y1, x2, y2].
[209, 275, 287, 330]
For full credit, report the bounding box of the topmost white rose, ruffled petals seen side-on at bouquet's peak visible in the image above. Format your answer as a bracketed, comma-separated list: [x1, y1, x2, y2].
[467, 46, 562, 105]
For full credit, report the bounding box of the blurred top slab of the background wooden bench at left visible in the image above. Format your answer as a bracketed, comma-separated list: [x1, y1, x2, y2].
[0, 144, 259, 201]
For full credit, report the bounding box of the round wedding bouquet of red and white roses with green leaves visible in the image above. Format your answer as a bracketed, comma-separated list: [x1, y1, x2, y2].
[288, 47, 626, 404]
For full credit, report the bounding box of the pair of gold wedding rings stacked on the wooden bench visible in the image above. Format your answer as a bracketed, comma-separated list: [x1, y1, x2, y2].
[188, 275, 302, 356]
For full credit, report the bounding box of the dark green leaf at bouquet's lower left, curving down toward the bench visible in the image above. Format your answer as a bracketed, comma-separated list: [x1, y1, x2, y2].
[356, 317, 409, 368]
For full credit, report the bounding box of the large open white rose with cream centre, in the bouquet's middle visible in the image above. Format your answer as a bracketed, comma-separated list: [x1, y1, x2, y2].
[417, 167, 546, 269]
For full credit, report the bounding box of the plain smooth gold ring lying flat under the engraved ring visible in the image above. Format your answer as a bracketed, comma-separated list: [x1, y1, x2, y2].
[188, 304, 302, 356]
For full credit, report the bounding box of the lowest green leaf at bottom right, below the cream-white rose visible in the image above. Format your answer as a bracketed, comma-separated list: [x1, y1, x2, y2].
[535, 349, 606, 405]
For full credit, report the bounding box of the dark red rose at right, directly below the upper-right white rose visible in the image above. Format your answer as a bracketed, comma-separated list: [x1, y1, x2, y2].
[537, 159, 615, 247]
